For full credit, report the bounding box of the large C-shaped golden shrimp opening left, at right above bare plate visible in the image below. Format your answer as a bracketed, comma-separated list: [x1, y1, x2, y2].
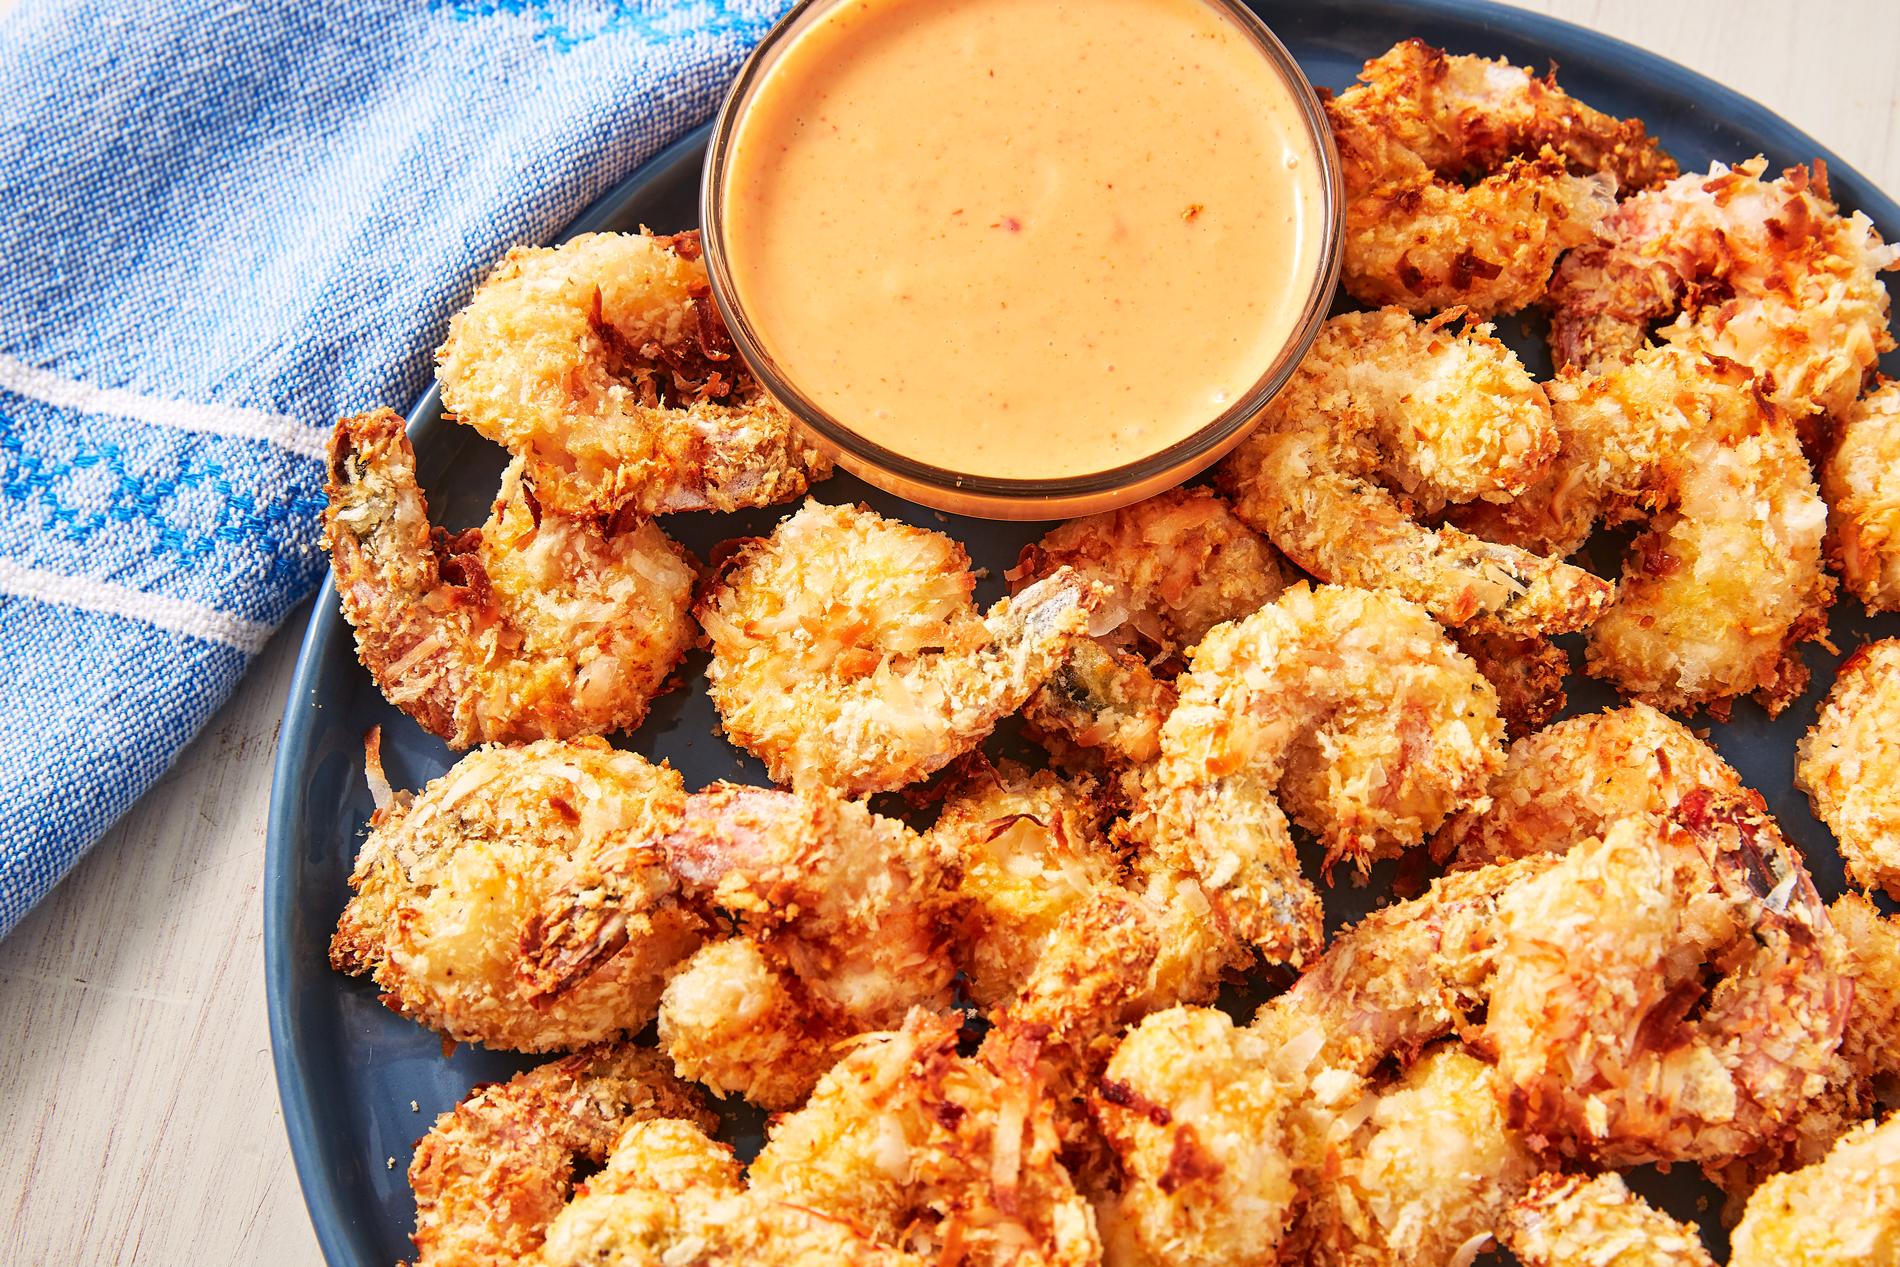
[1461, 348, 1834, 718]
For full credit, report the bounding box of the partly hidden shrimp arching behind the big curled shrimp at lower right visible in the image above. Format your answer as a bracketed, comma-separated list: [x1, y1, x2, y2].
[1431, 703, 1742, 868]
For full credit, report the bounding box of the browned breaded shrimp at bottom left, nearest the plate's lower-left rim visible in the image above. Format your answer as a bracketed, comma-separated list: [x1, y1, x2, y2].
[409, 1043, 718, 1267]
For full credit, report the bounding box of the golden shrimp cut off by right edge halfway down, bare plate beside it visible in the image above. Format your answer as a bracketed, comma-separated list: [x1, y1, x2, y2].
[1794, 638, 1900, 898]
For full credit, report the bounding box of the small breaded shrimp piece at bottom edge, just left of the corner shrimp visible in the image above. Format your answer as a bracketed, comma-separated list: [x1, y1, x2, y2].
[1501, 1172, 1716, 1267]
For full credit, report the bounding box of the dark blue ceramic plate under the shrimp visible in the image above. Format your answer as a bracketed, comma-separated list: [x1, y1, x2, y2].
[264, 0, 1900, 1267]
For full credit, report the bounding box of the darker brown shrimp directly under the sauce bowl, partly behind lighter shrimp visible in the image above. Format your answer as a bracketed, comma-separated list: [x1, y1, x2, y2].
[1009, 486, 1290, 766]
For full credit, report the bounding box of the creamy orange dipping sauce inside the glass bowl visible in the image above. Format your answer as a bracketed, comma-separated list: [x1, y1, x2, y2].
[724, 0, 1322, 479]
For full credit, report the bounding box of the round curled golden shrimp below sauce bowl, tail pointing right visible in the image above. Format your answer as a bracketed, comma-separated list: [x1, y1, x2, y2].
[697, 501, 1102, 796]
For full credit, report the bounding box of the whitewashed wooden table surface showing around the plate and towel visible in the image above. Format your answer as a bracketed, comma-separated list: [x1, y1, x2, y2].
[0, 0, 1900, 1267]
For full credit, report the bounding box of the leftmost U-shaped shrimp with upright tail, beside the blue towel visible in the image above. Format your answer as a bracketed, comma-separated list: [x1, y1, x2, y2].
[323, 408, 697, 748]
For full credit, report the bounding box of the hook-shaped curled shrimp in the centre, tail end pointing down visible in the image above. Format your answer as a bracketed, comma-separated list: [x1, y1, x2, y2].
[1131, 583, 1503, 888]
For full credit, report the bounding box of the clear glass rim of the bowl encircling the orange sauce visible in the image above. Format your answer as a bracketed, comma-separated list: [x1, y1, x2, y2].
[699, 0, 1345, 519]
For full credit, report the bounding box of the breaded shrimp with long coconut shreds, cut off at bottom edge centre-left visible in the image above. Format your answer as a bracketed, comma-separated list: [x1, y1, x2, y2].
[751, 1011, 1102, 1267]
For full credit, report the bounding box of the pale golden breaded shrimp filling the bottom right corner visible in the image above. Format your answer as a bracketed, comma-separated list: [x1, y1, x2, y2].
[1729, 1115, 1900, 1267]
